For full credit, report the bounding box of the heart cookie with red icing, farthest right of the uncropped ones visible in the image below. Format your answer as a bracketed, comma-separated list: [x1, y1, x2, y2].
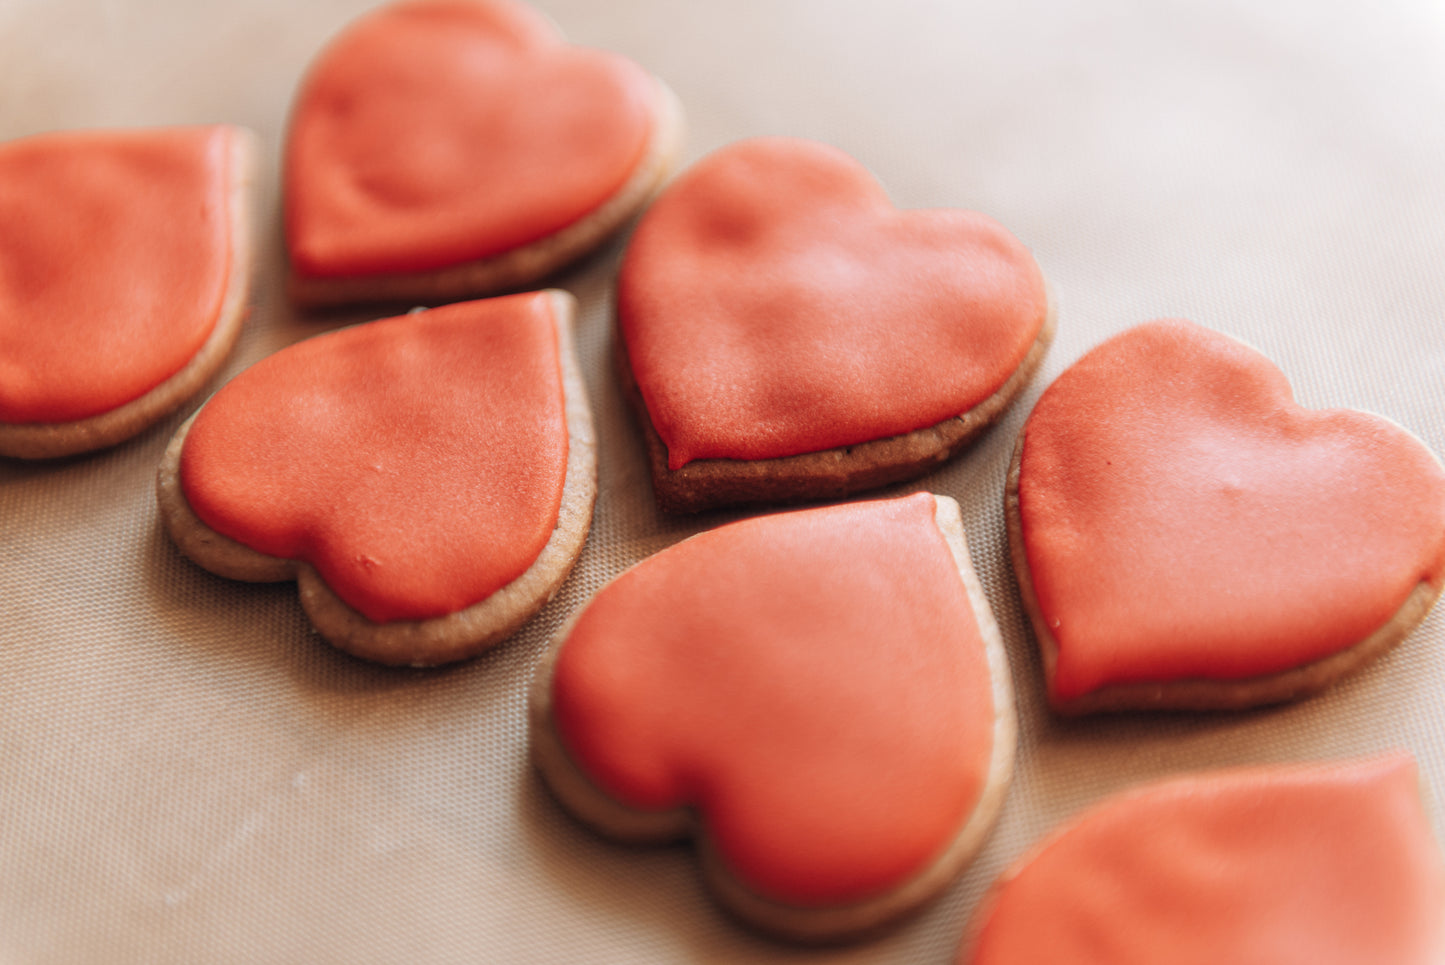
[1007, 321, 1445, 712]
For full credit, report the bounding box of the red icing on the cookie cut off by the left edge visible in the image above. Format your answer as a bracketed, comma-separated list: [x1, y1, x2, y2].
[0, 126, 237, 423]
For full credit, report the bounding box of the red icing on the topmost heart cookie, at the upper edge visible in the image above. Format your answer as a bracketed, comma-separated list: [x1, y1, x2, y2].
[285, 0, 657, 277]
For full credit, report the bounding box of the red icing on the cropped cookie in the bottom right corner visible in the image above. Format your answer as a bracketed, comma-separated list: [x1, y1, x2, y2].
[961, 756, 1445, 965]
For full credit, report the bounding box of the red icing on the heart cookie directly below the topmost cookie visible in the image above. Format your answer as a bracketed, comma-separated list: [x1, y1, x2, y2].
[181, 292, 568, 623]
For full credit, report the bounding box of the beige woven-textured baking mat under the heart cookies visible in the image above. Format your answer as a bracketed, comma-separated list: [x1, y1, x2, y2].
[0, 0, 1445, 965]
